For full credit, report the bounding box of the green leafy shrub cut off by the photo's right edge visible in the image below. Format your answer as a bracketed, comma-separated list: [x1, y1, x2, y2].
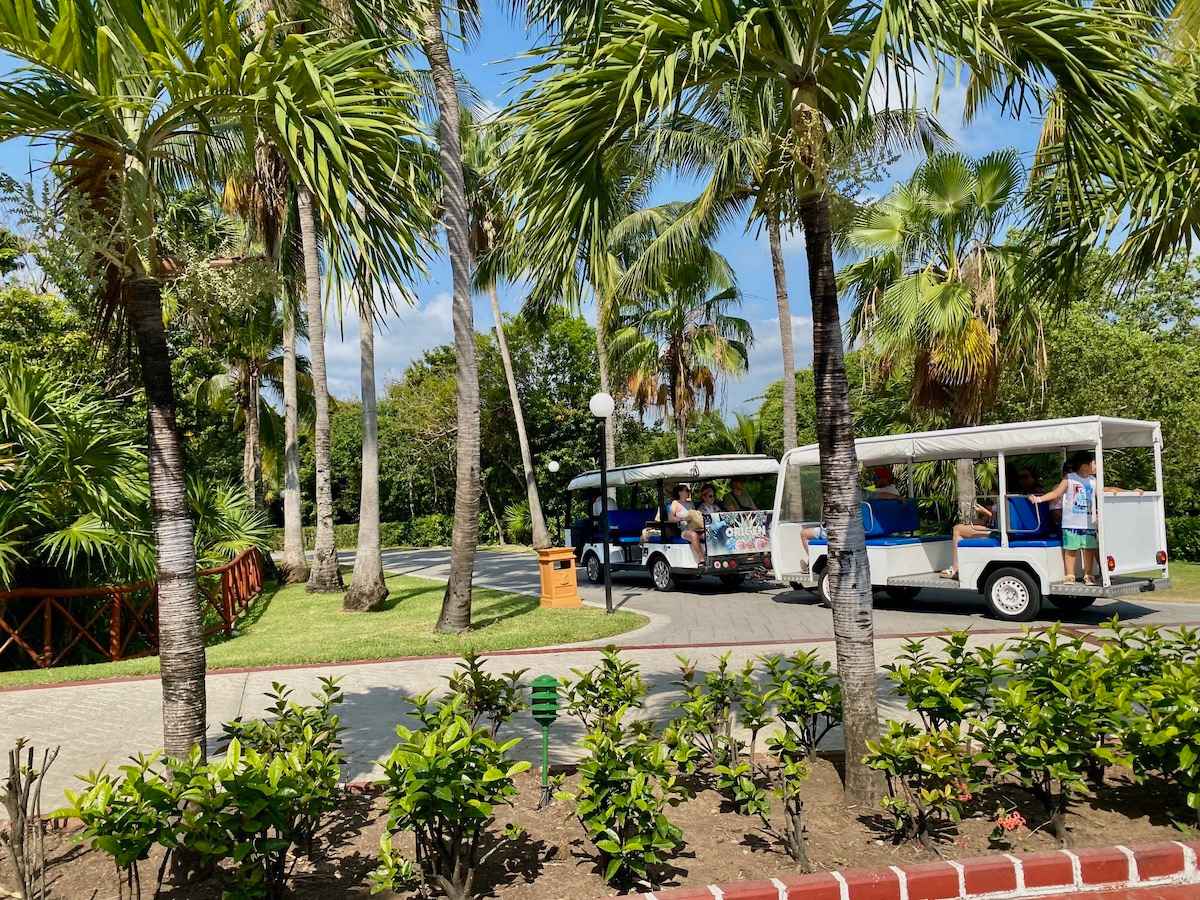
[1124, 661, 1200, 824]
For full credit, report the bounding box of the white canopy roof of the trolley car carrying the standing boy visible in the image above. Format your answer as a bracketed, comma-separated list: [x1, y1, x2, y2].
[784, 415, 1162, 466]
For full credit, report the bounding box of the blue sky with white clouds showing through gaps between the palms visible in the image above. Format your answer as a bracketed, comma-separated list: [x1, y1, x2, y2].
[0, 0, 1038, 414]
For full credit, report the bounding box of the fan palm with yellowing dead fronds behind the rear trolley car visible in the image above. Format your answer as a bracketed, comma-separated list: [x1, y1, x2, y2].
[838, 150, 1046, 522]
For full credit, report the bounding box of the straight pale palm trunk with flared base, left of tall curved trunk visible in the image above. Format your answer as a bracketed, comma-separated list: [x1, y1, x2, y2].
[342, 304, 388, 612]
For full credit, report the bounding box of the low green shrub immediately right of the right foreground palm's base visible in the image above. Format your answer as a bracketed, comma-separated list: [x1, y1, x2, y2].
[863, 721, 978, 846]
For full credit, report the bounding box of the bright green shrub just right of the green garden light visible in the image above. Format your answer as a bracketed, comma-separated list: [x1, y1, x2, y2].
[559, 709, 685, 887]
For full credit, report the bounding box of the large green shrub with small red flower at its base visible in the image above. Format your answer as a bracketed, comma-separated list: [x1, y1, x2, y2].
[970, 625, 1130, 844]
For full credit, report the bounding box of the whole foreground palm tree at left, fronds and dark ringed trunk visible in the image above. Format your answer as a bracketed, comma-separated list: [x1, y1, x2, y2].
[0, 0, 432, 756]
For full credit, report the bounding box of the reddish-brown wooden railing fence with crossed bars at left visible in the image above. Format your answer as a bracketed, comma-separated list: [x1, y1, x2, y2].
[0, 548, 264, 670]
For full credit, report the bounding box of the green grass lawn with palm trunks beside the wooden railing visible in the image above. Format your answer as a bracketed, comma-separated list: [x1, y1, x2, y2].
[0, 575, 647, 688]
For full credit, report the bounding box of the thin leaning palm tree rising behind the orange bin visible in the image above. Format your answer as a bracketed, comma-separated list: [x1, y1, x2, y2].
[462, 109, 550, 550]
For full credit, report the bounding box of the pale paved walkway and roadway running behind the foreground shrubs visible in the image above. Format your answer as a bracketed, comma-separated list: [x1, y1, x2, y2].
[0, 551, 1200, 804]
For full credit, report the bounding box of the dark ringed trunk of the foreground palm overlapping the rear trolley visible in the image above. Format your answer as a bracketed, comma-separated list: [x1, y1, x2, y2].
[800, 183, 881, 806]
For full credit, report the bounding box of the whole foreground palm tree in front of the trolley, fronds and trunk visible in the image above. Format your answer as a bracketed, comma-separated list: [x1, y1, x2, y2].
[514, 0, 1157, 803]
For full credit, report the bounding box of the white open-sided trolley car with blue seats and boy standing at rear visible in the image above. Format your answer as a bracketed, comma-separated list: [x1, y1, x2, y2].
[772, 416, 1169, 622]
